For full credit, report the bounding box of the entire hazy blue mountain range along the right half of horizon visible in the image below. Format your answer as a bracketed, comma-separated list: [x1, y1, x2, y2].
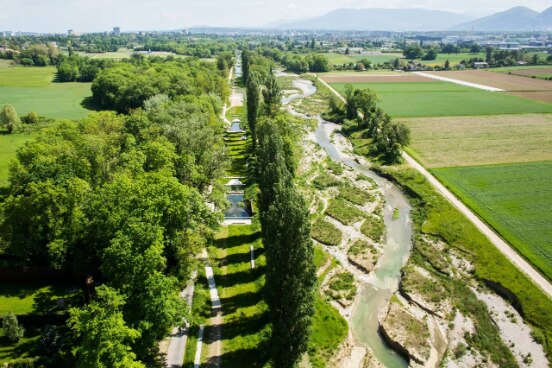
[267, 6, 552, 32]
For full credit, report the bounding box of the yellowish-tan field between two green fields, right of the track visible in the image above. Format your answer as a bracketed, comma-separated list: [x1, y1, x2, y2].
[406, 114, 552, 168]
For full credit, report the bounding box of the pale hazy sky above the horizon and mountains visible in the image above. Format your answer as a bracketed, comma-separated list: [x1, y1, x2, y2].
[0, 0, 552, 32]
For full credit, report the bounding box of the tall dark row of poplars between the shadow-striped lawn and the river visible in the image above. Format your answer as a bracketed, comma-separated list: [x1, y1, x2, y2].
[242, 50, 316, 368]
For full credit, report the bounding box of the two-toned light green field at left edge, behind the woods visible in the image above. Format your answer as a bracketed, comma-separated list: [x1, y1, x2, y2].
[0, 67, 92, 119]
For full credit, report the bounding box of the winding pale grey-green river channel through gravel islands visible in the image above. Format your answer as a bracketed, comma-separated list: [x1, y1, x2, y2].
[282, 79, 412, 368]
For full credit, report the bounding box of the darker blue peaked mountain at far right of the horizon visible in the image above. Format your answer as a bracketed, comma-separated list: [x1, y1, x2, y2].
[450, 6, 552, 31]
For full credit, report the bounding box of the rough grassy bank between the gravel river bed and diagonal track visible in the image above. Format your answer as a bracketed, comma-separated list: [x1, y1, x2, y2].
[378, 165, 552, 359]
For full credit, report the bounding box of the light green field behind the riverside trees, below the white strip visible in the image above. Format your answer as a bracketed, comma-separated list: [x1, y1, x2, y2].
[331, 82, 552, 118]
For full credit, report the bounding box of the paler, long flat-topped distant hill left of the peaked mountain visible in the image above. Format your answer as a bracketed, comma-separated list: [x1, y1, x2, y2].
[267, 8, 474, 31]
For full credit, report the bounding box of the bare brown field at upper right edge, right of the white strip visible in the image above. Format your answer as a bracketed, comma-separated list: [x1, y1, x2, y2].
[428, 70, 552, 93]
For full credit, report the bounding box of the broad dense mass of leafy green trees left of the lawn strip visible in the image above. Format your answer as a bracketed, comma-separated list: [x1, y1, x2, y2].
[0, 56, 228, 368]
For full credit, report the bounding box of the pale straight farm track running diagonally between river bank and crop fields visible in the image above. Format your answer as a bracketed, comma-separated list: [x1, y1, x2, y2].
[317, 76, 552, 298]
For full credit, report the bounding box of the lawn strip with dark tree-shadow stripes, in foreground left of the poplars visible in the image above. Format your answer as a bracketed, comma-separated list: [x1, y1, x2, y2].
[212, 225, 270, 367]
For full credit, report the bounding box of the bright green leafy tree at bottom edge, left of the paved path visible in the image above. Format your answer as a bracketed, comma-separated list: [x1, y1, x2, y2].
[68, 285, 145, 368]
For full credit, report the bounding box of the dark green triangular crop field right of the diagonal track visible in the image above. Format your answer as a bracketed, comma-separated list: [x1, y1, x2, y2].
[433, 162, 552, 279]
